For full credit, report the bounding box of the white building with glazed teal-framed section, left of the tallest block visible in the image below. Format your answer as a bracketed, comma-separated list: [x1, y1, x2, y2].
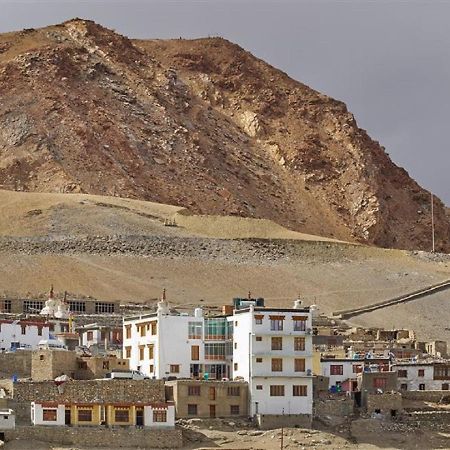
[123, 296, 231, 379]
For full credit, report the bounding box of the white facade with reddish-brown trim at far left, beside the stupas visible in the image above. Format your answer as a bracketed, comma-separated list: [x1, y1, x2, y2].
[0, 320, 50, 350]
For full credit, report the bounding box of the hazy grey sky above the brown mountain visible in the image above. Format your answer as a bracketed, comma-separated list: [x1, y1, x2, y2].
[0, 0, 450, 205]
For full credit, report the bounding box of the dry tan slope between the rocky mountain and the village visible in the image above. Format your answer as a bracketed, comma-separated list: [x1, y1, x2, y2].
[0, 191, 450, 339]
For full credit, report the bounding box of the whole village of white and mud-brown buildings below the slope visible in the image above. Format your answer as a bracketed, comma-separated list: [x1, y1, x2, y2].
[0, 287, 450, 448]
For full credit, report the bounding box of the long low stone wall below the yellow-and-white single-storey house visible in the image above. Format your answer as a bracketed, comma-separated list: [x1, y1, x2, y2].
[5, 426, 183, 449]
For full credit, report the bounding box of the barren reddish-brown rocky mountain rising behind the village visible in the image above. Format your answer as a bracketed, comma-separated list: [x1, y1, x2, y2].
[0, 19, 450, 251]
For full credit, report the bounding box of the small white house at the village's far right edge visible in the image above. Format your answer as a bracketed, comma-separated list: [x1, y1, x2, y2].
[393, 362, 450, 391]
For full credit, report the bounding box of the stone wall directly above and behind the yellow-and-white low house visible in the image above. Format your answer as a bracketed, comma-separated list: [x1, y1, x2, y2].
[12, 379, 165, 424]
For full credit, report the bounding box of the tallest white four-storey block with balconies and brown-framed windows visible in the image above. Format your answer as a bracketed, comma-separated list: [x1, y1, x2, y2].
[229, 306, 313, 415]
